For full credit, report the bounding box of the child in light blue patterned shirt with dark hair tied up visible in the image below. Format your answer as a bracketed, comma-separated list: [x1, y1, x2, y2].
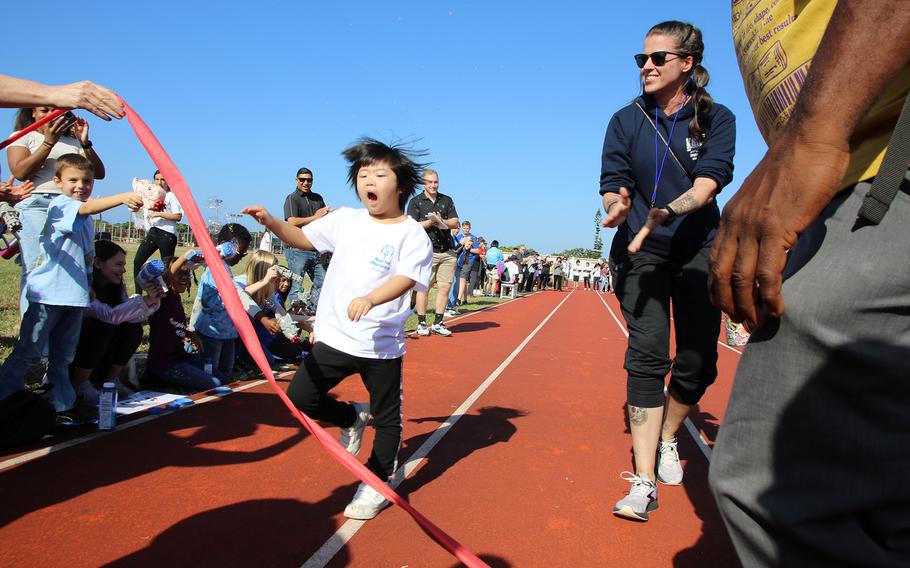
[190, 223, 252, 378]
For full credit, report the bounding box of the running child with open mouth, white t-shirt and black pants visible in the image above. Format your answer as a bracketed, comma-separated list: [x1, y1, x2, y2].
[243, 139, 433, 519]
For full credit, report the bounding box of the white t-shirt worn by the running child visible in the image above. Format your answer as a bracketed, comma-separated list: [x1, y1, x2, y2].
[303, 207, 433, 359]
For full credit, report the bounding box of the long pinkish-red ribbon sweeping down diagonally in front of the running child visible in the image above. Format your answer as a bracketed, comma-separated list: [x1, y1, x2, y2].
[126, 102, 489, 568]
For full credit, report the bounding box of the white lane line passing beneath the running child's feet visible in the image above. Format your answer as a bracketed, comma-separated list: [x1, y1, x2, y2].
[301, 290, 574, 568]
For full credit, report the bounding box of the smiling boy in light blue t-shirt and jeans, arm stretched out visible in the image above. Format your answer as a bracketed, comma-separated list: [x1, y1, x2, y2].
[0, 154, 142, 412]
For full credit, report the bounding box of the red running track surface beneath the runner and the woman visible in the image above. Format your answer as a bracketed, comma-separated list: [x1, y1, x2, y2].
[0, 291, 738, 567]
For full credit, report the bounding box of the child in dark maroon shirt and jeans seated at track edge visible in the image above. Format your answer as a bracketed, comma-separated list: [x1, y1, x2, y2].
[145, 251, 228, 390]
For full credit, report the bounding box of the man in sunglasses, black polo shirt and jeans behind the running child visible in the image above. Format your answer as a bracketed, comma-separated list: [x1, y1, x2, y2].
[284, 168, 331, 314]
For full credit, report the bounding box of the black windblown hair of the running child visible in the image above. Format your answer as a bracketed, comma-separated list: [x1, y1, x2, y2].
[341, 137, 429, 211]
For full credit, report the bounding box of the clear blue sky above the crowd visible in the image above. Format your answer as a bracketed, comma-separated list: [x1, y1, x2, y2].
[0, 0, 765, 252]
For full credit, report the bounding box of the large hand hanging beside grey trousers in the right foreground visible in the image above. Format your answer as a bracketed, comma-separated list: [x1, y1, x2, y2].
[708, 136, 850, 329]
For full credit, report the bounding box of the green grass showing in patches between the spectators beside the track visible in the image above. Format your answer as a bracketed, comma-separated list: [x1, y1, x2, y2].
[0, 243, 502, 360]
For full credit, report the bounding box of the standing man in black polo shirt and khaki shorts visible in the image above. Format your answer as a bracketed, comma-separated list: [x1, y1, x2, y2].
[408, 170, 458, 337]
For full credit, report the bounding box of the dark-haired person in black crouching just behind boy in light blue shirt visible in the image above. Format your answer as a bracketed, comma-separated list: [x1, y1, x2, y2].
[70, 240, 164, 406]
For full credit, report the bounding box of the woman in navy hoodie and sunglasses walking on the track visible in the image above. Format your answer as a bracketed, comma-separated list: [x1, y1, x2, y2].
[600, 21, 736, 521]
